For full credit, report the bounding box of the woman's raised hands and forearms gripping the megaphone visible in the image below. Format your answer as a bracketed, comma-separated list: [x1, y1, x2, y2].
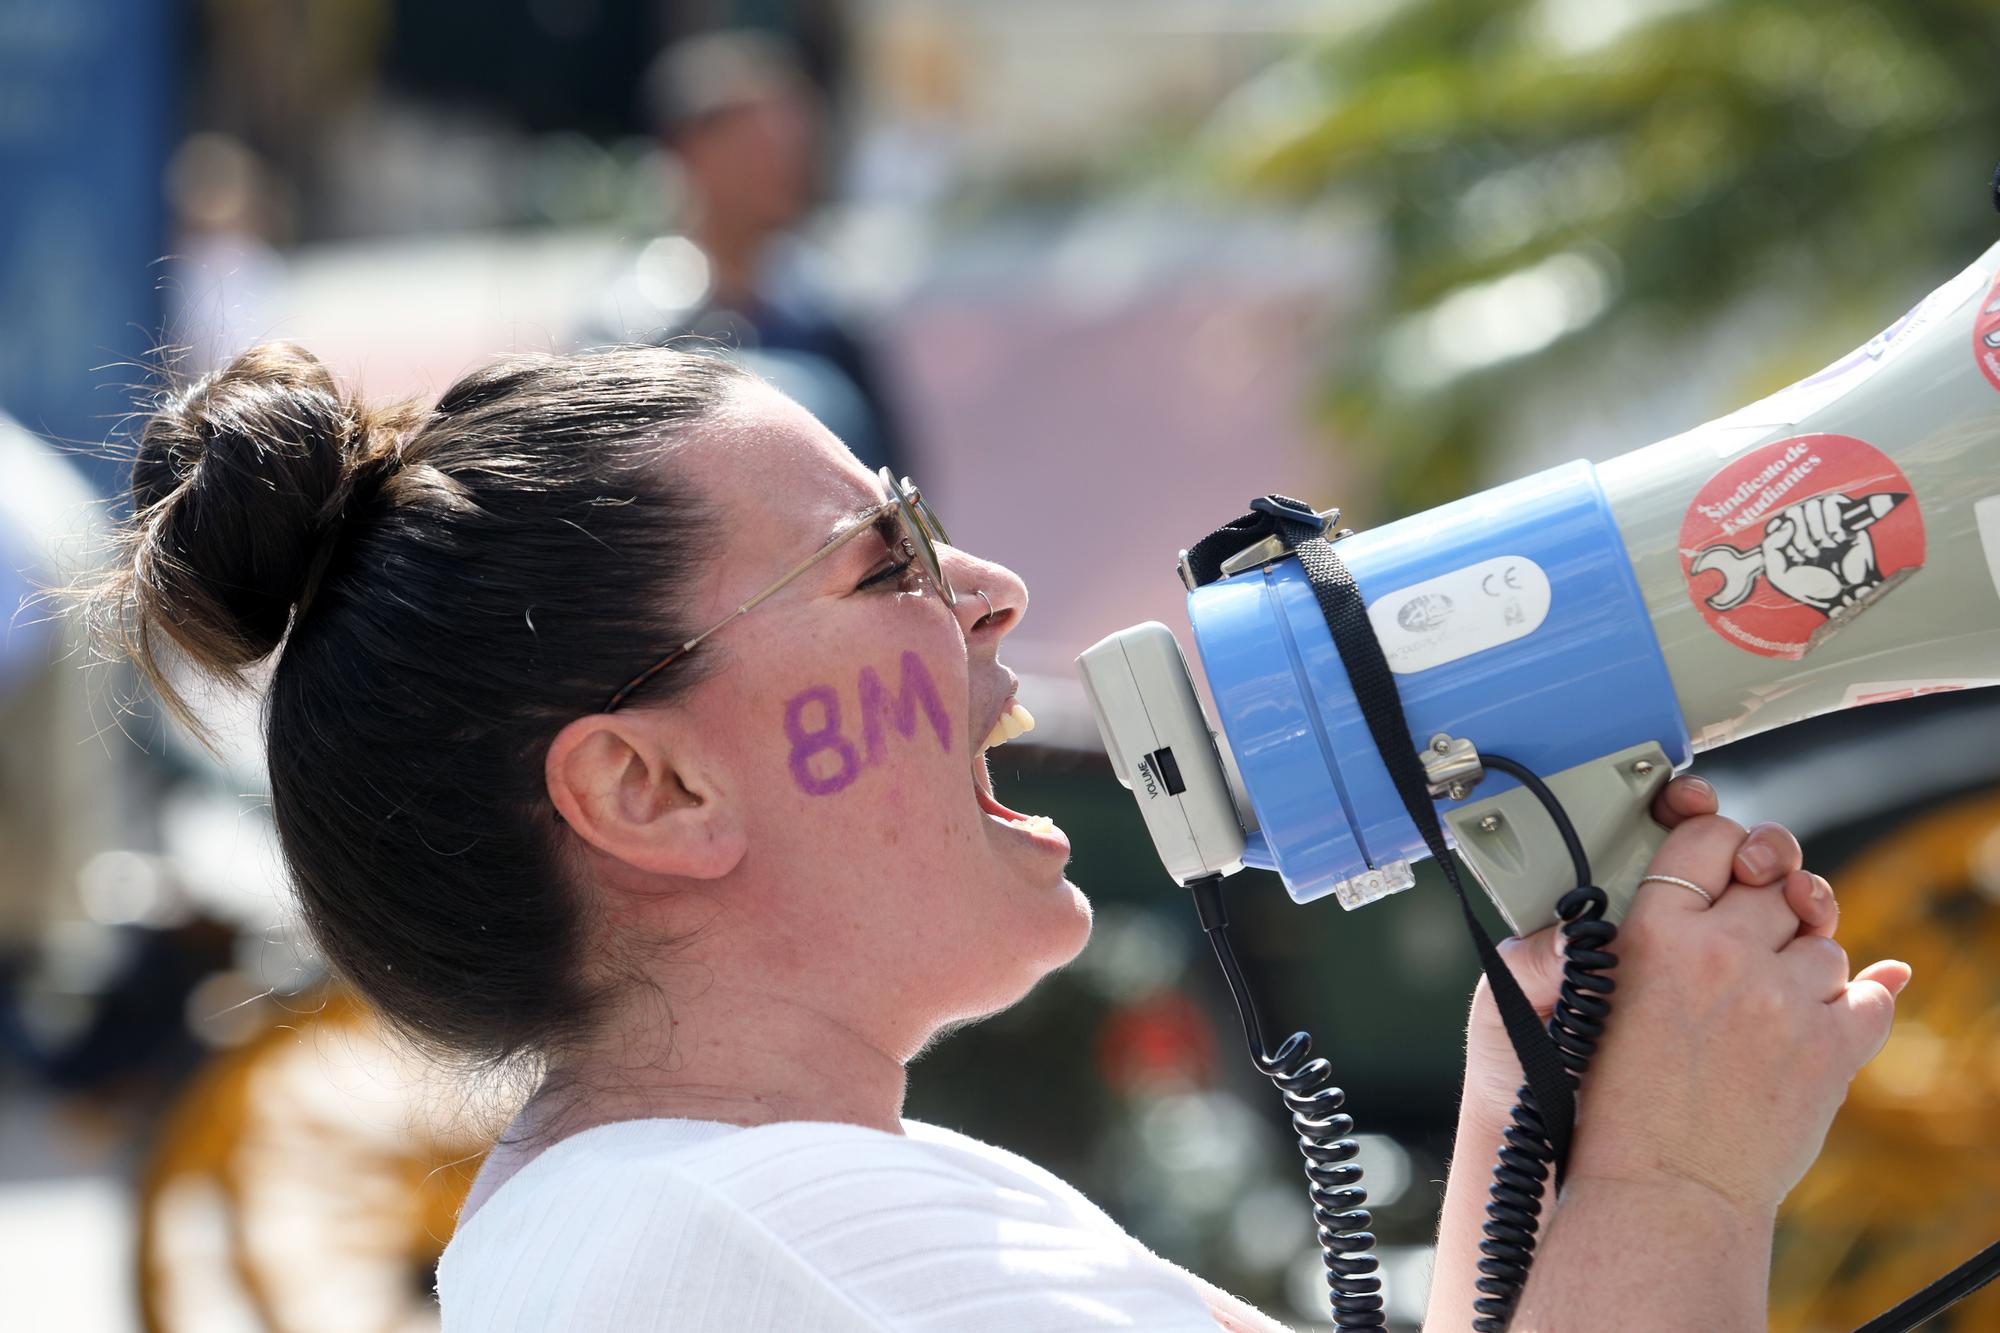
[1426, 779, 1910, 1333]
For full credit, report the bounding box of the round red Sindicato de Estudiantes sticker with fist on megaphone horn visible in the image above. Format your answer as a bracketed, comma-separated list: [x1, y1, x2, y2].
[1680, 436, 1928, 658]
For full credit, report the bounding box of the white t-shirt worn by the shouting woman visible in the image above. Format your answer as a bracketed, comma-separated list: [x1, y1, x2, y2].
[438, 1119, 1216, 1333]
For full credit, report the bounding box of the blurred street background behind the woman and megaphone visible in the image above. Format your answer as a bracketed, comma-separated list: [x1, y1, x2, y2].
[0, 0, 2000, 1333]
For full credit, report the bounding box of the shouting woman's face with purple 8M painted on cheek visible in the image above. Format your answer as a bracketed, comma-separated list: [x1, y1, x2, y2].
[656, 382, 1090, 1045]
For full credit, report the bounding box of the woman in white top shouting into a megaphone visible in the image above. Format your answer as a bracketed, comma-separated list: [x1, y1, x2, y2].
[104, 344, 1908, 1333]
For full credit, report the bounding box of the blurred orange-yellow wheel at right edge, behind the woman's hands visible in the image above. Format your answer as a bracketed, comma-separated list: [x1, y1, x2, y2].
[1772, 789, 2000, 1333]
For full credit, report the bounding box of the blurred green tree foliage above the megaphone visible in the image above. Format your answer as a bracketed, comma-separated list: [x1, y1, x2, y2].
[1210, 0, 2000, 512]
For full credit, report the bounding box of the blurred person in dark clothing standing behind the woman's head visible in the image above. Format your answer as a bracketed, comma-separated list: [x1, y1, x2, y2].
[584, 30, 908, 476]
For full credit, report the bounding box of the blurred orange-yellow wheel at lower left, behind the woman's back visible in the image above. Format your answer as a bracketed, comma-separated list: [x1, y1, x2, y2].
[138, 987, 494, 1333]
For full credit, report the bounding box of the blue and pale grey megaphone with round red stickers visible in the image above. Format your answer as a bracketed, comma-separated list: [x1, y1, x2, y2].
[1078, 233, 2000, 933]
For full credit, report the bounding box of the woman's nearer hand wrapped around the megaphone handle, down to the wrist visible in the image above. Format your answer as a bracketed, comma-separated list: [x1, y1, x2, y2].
[1568, 815, 1910, 1223]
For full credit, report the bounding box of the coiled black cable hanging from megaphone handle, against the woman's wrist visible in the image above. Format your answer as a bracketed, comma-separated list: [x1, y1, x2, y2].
[1472, 753, 1618, 1333]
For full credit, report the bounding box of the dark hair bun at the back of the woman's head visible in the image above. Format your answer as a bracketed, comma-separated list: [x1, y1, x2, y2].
[132, 342, 380, 673]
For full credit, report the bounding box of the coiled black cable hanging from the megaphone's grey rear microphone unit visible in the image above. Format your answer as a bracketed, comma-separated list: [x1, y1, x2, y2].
[1188, 875, 1386, 1329]
